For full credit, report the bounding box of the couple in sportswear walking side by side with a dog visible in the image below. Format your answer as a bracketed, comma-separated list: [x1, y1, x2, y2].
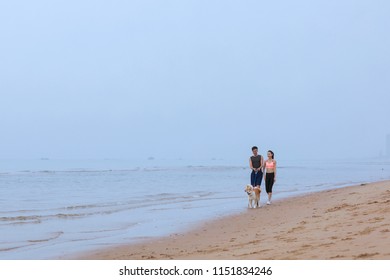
[249, 146, 276, 204]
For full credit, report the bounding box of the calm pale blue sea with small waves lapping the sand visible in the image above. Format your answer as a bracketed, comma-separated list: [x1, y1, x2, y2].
[0, 158, 390, 260]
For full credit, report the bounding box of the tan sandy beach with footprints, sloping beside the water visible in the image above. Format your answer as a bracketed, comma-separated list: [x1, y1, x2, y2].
[77, 181, 390, 260]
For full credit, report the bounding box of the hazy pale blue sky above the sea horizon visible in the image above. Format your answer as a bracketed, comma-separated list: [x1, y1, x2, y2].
[0, 0, 390, 161]
